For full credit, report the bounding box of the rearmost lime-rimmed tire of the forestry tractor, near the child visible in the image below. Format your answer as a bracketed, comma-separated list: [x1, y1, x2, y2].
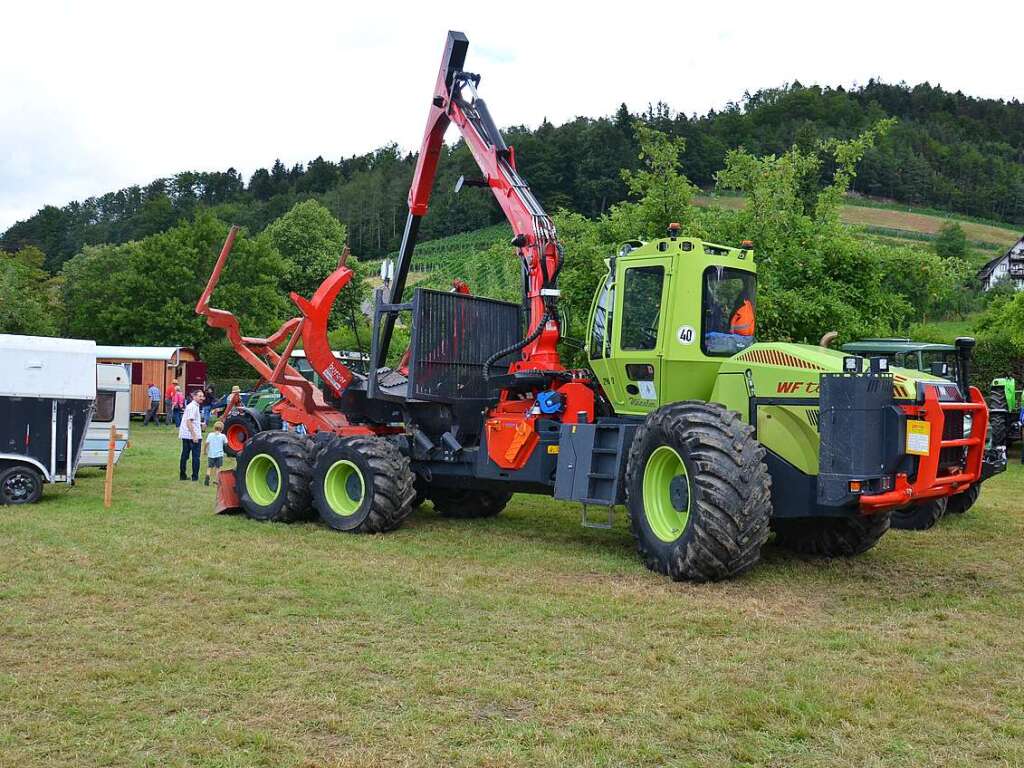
[234, 432, 311, 522]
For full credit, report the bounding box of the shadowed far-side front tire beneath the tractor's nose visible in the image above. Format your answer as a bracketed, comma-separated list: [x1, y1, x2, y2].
[772, 512, 889, 557]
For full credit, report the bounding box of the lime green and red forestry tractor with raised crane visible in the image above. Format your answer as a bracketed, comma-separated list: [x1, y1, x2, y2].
[197, 32, 1005, 581]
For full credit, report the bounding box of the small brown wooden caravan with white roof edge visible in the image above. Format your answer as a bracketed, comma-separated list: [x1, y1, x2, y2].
[96, 344, 206, 416]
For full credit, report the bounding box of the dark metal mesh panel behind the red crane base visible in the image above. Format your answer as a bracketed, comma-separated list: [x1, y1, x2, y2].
[409, 288, 522, 401]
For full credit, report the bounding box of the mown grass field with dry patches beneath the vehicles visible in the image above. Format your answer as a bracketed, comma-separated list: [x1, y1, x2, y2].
[0, 425, 1024, 768]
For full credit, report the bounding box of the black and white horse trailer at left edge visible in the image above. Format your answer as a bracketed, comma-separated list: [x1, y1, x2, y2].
[0, 334, 96, 504]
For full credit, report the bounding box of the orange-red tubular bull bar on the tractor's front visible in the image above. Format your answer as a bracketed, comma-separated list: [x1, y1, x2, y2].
[860, 386, 988, 513]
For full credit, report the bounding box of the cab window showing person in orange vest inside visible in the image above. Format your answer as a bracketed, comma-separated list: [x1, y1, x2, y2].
[700, 266, 757, 356]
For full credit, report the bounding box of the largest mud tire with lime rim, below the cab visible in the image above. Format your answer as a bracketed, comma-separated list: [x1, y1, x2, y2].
[625, 400, 771, 582]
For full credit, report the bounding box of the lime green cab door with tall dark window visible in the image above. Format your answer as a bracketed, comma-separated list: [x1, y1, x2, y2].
[608, 258, 671, 414]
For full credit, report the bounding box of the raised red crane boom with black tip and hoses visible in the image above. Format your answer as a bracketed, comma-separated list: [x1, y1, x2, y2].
[378, 32, 563, 378]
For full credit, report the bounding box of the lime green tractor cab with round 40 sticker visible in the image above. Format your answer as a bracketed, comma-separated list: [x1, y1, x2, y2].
[587, 230, 757, 415]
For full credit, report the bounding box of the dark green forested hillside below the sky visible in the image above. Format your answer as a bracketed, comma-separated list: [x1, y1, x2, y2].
[6, 81, 1024, 273]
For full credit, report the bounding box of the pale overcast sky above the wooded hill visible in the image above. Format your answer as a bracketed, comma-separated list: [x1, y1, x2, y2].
[0, 0, 1024, 231]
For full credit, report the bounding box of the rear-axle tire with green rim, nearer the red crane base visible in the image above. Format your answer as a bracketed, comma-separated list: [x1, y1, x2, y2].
[311, 435, 416, 534]
